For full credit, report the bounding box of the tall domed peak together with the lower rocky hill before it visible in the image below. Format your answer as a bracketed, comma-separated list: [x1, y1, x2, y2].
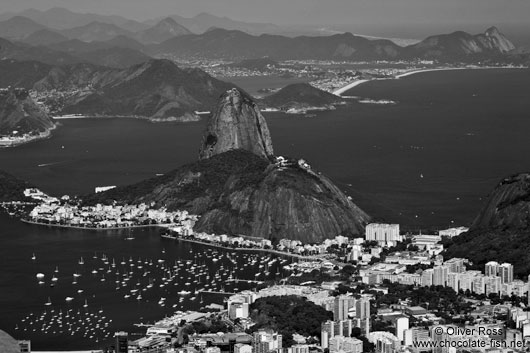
[84, 89, 370, 243]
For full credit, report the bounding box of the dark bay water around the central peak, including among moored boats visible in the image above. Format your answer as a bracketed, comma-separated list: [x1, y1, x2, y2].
[0, 70, 530, 349]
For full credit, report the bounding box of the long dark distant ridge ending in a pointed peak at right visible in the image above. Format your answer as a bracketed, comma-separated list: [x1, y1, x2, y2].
[152, 27, 515, 62]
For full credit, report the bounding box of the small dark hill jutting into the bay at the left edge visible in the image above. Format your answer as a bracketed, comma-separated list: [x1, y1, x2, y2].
[0, 88, 54, 136]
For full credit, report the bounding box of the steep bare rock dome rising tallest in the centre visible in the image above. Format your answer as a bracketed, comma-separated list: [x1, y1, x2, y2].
[199, 88, 274, 159]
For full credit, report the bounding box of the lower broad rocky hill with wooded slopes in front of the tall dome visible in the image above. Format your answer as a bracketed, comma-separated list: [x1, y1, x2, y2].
[88, 149, 370, 243]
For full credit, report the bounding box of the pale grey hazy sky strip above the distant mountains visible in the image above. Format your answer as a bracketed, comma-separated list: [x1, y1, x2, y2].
[0, 0, 530, 25]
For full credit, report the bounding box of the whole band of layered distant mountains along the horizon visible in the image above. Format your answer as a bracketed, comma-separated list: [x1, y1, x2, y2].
[0, 9, 528, 67]
